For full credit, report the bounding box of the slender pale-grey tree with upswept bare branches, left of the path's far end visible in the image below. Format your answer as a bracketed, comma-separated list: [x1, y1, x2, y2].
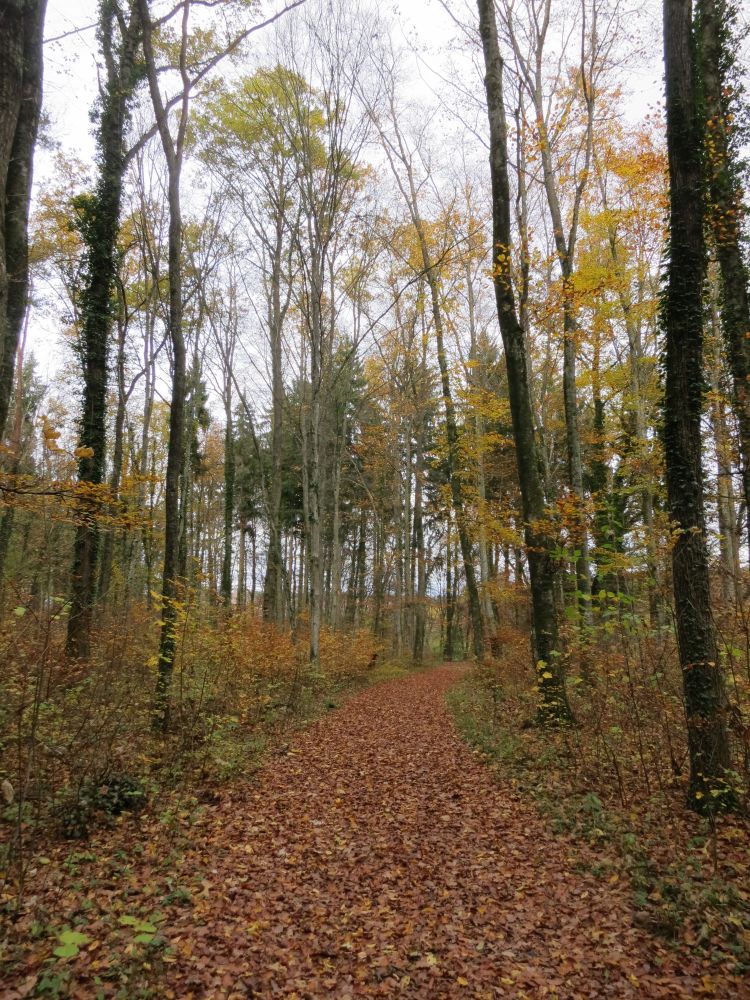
[280, 4, 374, 665]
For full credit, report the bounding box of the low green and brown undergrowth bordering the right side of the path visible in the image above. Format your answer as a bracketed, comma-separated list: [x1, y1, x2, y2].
[448, 652, 750, 972]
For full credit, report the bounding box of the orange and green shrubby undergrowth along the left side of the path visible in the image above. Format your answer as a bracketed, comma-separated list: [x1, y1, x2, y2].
[0, 606, 406, 912]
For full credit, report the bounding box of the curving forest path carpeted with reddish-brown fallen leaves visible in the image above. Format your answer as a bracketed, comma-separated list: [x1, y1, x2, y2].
[154, 666, 724, 1000]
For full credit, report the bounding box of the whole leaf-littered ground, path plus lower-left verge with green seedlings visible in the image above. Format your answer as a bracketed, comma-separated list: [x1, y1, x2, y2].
[0, 665, 750, 1000]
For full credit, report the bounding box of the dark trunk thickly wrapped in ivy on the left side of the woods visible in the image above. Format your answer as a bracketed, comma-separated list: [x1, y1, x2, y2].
[66, 0, 140, 657]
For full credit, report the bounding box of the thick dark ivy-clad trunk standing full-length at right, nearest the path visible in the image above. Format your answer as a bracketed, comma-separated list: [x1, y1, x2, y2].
[662, 0, 729, 812]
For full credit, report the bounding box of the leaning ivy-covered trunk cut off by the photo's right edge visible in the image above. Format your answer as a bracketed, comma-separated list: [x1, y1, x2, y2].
[697, 0, 750, 548]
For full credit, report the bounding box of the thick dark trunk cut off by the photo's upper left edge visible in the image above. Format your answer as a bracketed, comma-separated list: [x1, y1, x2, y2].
[0, 0, 47, 441]
